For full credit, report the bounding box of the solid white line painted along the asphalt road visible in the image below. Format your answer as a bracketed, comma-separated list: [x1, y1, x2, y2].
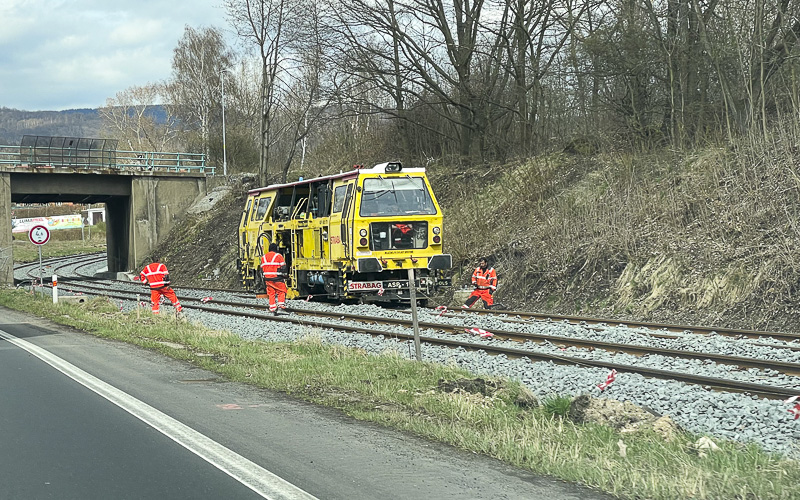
[0, 330, 316, 500]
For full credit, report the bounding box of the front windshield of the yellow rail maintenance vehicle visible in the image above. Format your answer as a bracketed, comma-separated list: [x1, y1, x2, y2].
[360, 177, 436, 217]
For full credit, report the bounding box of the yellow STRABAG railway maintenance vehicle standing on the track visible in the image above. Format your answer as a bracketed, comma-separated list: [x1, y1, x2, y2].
[237, 162, 452, 305]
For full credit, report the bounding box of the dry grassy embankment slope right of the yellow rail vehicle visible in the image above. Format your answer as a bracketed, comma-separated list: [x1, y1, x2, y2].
[433, 120, 800, 329]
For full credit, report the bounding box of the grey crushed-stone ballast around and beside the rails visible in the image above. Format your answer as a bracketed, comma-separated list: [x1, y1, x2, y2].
[23, 263, 800, 458]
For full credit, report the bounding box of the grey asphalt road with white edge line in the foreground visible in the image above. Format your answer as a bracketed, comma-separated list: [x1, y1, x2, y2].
[0, 308, 609, 500]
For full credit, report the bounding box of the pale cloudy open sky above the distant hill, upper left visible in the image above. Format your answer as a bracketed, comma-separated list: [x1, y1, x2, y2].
[0, 0, 228, 111]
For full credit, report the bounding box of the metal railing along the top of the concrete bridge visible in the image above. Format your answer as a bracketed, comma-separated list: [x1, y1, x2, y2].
[0, 146, 216, 175]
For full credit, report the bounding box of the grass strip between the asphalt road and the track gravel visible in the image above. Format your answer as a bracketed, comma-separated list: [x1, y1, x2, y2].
[0, 290, 800, 499]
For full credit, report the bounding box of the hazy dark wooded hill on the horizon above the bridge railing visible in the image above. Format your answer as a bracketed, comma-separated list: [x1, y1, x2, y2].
[0, 107, 103, 146]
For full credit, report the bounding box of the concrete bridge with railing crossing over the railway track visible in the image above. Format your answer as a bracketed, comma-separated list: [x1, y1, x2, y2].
[0, 136, 219, 284]
